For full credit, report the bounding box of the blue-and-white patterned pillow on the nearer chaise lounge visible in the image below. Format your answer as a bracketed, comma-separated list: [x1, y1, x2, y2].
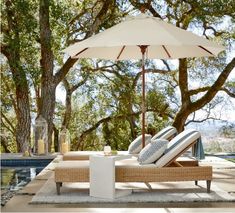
[138, 139, 169, 164]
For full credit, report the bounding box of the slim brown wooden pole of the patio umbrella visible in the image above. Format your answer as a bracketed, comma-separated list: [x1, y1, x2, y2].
[139, 45, 148, 148]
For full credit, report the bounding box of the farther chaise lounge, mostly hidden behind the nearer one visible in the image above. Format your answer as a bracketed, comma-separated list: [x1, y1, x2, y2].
[63, 126, 177, 160]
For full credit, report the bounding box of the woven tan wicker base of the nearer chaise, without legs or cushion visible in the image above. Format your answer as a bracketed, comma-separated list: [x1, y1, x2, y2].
[55, 161, 212, 182]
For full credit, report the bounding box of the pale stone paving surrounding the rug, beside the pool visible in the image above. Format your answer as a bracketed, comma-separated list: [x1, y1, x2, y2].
[1, 156, 235, 213]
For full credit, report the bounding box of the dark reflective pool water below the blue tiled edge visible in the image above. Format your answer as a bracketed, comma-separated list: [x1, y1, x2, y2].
[1, 167, 44, 191]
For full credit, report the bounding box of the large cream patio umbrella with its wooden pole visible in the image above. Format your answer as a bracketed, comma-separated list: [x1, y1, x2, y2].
[64, 14, 224, 147]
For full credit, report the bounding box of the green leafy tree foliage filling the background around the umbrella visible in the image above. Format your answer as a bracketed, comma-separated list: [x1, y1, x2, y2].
[1, 0, 235, 151]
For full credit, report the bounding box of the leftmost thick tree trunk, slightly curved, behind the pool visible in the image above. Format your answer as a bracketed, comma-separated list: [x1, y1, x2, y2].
[2, 1, 31, 153]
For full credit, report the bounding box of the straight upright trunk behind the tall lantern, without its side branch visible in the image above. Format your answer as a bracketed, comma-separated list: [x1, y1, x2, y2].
[39, 0, 56, 151]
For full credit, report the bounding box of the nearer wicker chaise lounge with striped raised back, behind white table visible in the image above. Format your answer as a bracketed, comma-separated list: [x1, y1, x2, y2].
[55, 128, 212, 194]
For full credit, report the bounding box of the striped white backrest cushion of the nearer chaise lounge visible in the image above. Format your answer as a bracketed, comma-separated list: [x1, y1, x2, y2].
[156, 129, 201, 167]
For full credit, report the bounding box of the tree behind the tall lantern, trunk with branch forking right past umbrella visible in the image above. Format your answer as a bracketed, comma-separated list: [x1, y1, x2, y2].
[39, 0, 125, 151]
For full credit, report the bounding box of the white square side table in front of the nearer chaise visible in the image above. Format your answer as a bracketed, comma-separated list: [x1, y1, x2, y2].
[89, 154, 132, 199]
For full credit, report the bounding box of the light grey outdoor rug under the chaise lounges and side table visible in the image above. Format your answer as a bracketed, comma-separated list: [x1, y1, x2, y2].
[30, 178, 235, 204]
